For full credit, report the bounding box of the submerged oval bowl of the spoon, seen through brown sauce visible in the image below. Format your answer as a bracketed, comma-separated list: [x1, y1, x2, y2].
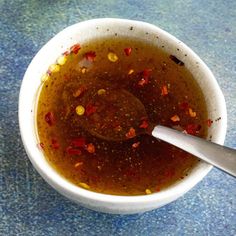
[77, 88, 147, 142]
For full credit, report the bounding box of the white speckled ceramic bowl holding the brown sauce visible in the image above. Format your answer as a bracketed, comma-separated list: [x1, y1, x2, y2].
[19, 18, 227, 214]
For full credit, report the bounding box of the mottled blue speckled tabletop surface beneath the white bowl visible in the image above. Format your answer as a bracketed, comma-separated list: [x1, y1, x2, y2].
[0, 0, 236, 236]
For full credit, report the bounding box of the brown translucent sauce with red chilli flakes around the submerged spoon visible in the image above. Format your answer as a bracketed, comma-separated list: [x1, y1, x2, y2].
[37, 37, 207, 195]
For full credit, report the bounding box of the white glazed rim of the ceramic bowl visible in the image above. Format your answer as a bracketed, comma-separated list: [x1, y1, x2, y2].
[18, 18, 227, 204]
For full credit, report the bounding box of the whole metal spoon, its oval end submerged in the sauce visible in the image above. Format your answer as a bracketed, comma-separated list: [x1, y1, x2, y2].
[80, 88, 236, 176]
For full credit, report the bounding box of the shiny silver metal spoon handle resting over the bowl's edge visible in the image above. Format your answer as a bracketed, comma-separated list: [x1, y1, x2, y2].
[152, 125, 236, 177]
